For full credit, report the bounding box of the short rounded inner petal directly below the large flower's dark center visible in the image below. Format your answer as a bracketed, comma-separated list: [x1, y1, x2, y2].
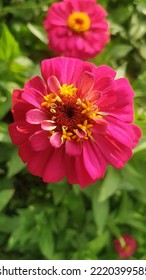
[65, 140, 82, 156]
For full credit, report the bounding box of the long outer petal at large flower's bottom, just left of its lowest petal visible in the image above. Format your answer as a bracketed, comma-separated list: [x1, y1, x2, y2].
[43, 146, 65, 183]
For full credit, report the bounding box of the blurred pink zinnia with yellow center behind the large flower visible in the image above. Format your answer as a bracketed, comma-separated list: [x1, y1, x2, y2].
[44, 0, 109, 60]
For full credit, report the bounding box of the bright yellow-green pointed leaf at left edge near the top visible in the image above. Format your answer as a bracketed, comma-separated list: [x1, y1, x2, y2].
[0, 24, 20, 63]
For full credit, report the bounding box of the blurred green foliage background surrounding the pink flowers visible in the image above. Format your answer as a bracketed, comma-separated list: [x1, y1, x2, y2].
[0, 0, 146, 260]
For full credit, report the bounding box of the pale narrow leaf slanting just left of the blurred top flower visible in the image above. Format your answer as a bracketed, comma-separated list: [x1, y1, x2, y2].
[27, 23, 48, 44]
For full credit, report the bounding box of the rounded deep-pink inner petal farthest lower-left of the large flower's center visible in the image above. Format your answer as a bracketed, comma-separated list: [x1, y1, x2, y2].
[29, 130, 50, 151]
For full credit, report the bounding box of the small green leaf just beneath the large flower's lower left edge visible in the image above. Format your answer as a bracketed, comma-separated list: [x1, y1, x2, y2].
[7, 148, 25, 178]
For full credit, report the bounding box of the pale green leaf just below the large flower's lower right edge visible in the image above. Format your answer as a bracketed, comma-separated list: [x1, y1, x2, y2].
[98, 168, 120, 202]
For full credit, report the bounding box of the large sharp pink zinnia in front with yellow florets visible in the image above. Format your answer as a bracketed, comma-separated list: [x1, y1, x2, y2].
[9, 58, 141, 187]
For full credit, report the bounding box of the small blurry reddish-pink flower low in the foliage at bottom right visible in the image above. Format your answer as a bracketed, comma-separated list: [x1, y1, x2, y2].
[114, 234, 137, 259]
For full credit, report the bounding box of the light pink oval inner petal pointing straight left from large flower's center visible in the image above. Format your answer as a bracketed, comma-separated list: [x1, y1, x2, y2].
[26, 109, 48, 124]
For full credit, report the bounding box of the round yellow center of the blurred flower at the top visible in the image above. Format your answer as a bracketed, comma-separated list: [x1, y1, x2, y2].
[67, 12, 91, 33]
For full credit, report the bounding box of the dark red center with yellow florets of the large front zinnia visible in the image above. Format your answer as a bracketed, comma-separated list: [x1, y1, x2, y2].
[41, 84, 102, 143]
